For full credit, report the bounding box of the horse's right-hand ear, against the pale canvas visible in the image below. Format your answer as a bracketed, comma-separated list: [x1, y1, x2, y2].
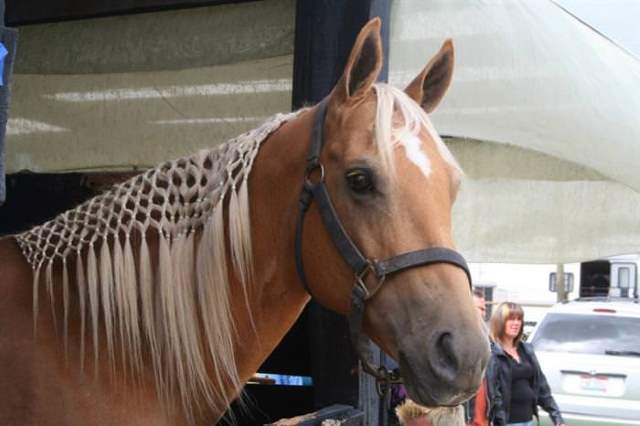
[404, 39, 454, 113]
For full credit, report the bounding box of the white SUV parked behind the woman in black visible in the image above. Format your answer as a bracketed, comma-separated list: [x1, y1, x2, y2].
[529, 298, 640, 426]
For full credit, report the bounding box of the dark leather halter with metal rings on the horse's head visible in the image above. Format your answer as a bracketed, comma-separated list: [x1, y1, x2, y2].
[295, 98, 471, 384]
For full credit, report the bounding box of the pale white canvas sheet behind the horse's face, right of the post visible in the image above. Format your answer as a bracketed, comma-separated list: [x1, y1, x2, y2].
[390, 0, 640, 263]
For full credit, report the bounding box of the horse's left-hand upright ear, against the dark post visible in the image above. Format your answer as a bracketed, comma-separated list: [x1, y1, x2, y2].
[333, 18, 382, 102]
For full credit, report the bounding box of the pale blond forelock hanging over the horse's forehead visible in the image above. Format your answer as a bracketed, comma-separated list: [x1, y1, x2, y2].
[374, 83, 462, 181]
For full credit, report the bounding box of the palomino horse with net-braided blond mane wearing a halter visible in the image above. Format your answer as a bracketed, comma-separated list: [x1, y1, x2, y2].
[0, 19, 488, 426]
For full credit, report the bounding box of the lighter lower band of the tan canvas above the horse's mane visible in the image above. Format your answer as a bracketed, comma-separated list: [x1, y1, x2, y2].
[6, 56, 292, 173]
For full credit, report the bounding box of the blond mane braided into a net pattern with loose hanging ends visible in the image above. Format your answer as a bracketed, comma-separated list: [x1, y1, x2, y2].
[14, 109, 297, 419]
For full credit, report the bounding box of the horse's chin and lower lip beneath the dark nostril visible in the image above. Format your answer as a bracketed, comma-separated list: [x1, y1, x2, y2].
[398, 354, 477, 407]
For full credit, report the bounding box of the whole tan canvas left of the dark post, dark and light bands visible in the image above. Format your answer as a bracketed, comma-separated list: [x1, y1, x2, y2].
[6, 0, 295, 173]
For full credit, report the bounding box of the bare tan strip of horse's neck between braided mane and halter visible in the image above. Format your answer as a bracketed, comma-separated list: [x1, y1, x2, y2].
[233, 111, 312, 380]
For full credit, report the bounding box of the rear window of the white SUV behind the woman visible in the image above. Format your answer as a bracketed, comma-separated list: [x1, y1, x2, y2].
[531, 313, 640, 355]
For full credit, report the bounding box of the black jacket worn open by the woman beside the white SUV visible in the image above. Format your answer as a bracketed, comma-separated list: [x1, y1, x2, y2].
[487, 342, 564, 426]
